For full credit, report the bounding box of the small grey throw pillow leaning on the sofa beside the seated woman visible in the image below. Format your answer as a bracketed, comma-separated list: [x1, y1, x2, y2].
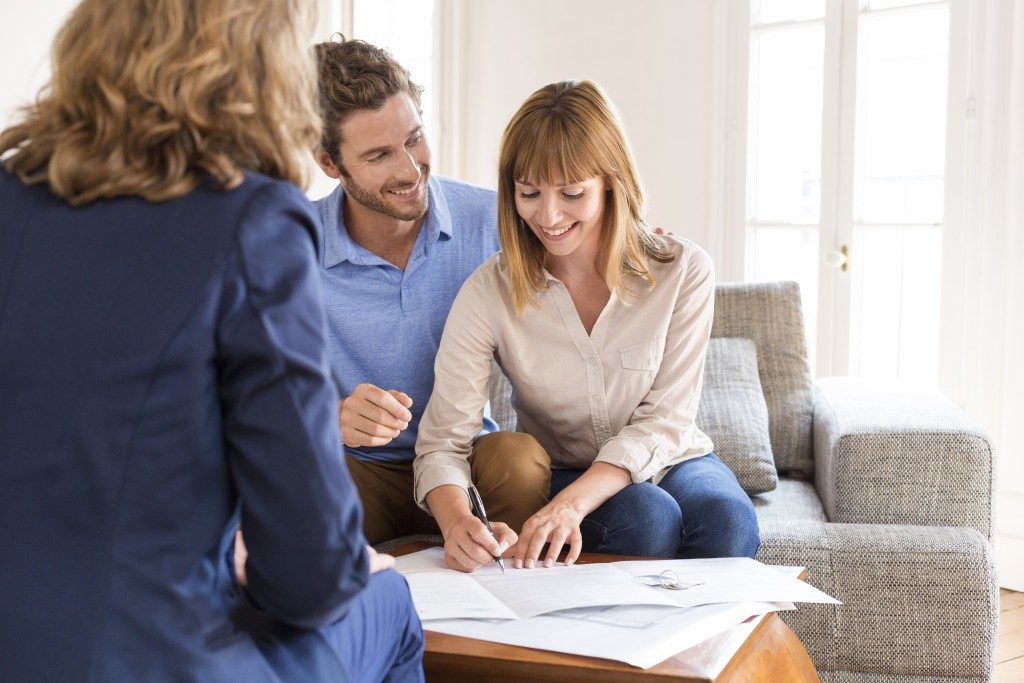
[696, 337, 778, 494]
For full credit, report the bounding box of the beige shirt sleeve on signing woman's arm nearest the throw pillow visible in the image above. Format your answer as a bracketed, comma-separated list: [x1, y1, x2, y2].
[596, 245, 715, 482]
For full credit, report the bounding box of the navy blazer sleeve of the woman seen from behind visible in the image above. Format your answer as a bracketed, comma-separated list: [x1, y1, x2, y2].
[217, 182, 369, 628]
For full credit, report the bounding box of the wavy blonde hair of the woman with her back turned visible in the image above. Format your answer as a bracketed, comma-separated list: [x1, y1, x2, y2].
[0, 0, 319, 204]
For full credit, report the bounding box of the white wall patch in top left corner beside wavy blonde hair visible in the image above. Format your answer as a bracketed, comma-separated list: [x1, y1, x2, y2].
[0, 0, 78, 128]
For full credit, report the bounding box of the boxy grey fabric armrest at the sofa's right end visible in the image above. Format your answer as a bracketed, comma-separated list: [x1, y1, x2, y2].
[814, 377, 992, 538]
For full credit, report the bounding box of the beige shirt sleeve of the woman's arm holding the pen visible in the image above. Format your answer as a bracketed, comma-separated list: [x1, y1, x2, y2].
[413, 264, 501, 512]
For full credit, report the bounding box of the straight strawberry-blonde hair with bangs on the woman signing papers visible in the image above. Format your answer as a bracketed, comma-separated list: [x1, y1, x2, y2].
[498, 81, 674, 313]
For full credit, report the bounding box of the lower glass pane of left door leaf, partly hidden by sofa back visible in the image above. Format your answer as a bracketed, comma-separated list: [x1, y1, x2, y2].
[748, 226, 818, 366]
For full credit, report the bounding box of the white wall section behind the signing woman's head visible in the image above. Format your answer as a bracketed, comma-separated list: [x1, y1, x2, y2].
[456, 0, 713, 250]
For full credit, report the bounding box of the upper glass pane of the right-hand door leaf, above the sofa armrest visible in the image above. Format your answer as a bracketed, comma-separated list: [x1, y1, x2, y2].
[854, 5, 949, 223]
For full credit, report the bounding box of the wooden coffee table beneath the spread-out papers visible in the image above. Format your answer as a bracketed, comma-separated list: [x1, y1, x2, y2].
[394, 543, 819, 683]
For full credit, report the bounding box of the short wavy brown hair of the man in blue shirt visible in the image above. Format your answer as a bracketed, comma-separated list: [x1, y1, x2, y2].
[314, 36, 423, 168]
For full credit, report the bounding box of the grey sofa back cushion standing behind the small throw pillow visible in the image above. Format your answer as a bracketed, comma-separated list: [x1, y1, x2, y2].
[711, 283, 814, 479]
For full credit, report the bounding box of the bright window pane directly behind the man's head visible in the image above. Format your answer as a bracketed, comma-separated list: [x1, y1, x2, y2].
[352, 0, 439, 154]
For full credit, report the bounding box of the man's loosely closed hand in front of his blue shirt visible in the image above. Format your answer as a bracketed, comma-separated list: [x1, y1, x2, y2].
[338, 384, 413, 449]
